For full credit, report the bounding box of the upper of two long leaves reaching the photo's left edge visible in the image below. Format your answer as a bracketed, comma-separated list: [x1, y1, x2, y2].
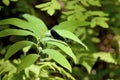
[0, 18, 36, 36]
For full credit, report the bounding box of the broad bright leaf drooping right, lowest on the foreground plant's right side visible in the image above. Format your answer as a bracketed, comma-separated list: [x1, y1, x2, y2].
[43, 49, 72, 72]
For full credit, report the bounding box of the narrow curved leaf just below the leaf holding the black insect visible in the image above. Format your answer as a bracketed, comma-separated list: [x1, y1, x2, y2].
[47, 41, 76, 63]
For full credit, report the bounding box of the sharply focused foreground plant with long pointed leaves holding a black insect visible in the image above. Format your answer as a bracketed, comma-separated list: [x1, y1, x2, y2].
[0, 14, 87, 79]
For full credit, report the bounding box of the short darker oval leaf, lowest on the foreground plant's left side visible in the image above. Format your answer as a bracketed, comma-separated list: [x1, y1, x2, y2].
[17, 54, 39, 72]
